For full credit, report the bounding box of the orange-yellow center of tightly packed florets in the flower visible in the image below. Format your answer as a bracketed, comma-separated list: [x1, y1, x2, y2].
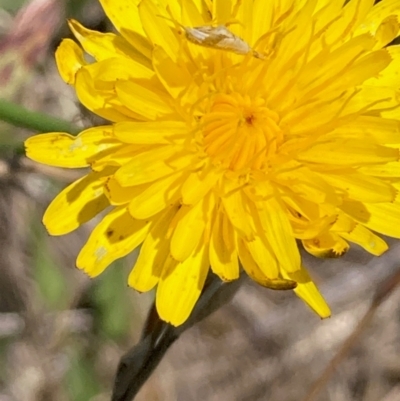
[203, 93, 283, 171]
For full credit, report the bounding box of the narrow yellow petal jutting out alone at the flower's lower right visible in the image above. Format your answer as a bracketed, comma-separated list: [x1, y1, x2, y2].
[283, 267, 331, 319]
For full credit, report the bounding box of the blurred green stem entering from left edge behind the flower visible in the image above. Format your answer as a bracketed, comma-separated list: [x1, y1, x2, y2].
[0, 99, 80, 134]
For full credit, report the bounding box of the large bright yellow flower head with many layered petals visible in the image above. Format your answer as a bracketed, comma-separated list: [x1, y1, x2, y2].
[26, 0, 400, 325]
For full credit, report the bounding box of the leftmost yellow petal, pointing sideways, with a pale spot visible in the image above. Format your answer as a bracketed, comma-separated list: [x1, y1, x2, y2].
[25, 126, 119, 168]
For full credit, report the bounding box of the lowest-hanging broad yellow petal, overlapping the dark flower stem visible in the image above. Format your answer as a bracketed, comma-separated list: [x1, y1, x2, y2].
[156, 246, 210, 326]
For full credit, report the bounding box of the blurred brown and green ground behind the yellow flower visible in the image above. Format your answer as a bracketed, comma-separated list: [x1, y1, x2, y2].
[0, 0, 400, 401]
